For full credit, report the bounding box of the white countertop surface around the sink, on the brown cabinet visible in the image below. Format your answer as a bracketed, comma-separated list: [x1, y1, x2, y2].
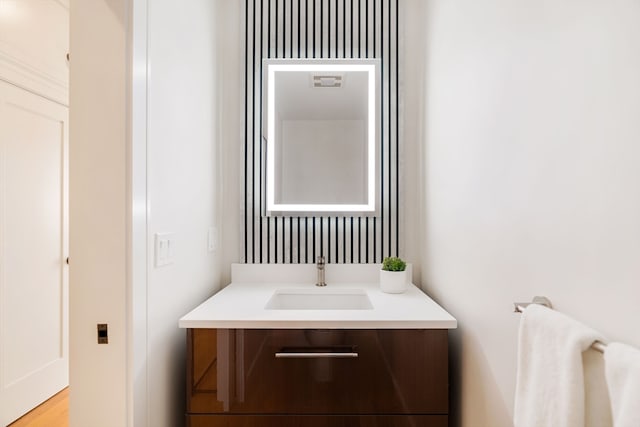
[179, 282, 457, 329]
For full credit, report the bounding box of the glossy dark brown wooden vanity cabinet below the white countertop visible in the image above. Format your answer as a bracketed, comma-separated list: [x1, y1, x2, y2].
[187, 329, 449, 427]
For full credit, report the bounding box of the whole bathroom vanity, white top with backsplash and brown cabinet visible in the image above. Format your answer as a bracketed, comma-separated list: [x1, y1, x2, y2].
[180, 265, 456, 427]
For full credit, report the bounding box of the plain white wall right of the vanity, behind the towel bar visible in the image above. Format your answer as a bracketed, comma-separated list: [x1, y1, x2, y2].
[405, 0, 640, 427]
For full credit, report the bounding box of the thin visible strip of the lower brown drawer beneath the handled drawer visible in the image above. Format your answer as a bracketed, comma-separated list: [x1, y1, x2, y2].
[187, 415, 448, 427]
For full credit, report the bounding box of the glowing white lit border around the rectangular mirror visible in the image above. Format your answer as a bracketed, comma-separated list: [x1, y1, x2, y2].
[264, 59, 380, 215]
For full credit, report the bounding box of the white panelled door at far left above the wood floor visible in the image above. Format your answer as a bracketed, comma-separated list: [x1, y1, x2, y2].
[0, 81, 69, 426]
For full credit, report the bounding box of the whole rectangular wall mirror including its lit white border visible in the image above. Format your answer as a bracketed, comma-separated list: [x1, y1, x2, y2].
[265, 60, 379, 216]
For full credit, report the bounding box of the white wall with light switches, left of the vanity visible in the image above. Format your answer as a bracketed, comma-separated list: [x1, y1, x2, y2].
[147, 0, 239, 427]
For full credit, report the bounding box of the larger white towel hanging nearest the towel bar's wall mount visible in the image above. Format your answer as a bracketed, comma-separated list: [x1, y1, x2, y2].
[513, 304, 601, 427]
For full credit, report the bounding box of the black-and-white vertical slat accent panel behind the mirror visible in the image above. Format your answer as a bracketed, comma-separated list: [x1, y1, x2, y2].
[244, 0, 400, 263]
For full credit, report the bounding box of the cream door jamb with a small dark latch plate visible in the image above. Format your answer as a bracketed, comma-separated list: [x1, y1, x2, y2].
[69, 0, 130, 427]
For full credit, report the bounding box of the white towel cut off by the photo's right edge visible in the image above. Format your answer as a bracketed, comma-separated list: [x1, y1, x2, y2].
[604, 343, 640, 427]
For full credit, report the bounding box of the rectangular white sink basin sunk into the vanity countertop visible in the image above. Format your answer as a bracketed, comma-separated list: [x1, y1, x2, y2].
[265, 288, 373, 310]
